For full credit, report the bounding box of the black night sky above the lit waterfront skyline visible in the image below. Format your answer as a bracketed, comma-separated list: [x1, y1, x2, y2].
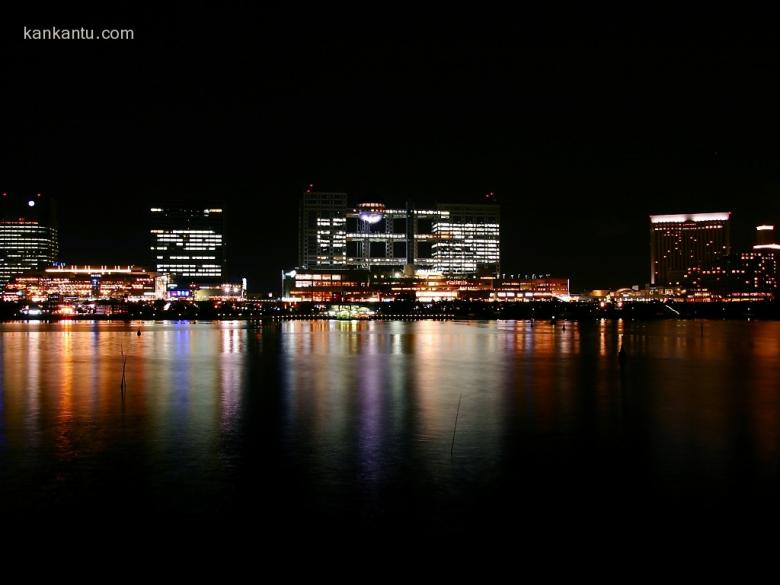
[0, 8, 780, 290]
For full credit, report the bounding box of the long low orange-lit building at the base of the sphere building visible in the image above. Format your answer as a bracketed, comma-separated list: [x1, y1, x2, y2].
[282, 269, 569, 303]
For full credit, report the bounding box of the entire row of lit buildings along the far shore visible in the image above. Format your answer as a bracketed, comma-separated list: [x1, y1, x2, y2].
[0, 185, 780, 314]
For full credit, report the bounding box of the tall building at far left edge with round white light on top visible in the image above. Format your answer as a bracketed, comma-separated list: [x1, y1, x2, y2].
[0, 193, 59, 285]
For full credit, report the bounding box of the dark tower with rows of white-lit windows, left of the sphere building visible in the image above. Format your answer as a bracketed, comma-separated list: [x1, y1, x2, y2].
[150, 205, 225, 286]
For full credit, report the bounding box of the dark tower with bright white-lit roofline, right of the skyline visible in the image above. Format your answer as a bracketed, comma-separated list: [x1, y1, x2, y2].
[650, 211, 731, 286]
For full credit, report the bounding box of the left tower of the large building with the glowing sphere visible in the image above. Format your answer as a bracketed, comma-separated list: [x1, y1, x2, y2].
[298, 185, 347, 267]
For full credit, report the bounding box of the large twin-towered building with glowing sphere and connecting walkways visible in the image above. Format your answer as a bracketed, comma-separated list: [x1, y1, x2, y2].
[298, 190, 501, 276]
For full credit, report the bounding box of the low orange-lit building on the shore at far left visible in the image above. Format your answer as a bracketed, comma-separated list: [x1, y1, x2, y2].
[3, 266, 157, 303]
